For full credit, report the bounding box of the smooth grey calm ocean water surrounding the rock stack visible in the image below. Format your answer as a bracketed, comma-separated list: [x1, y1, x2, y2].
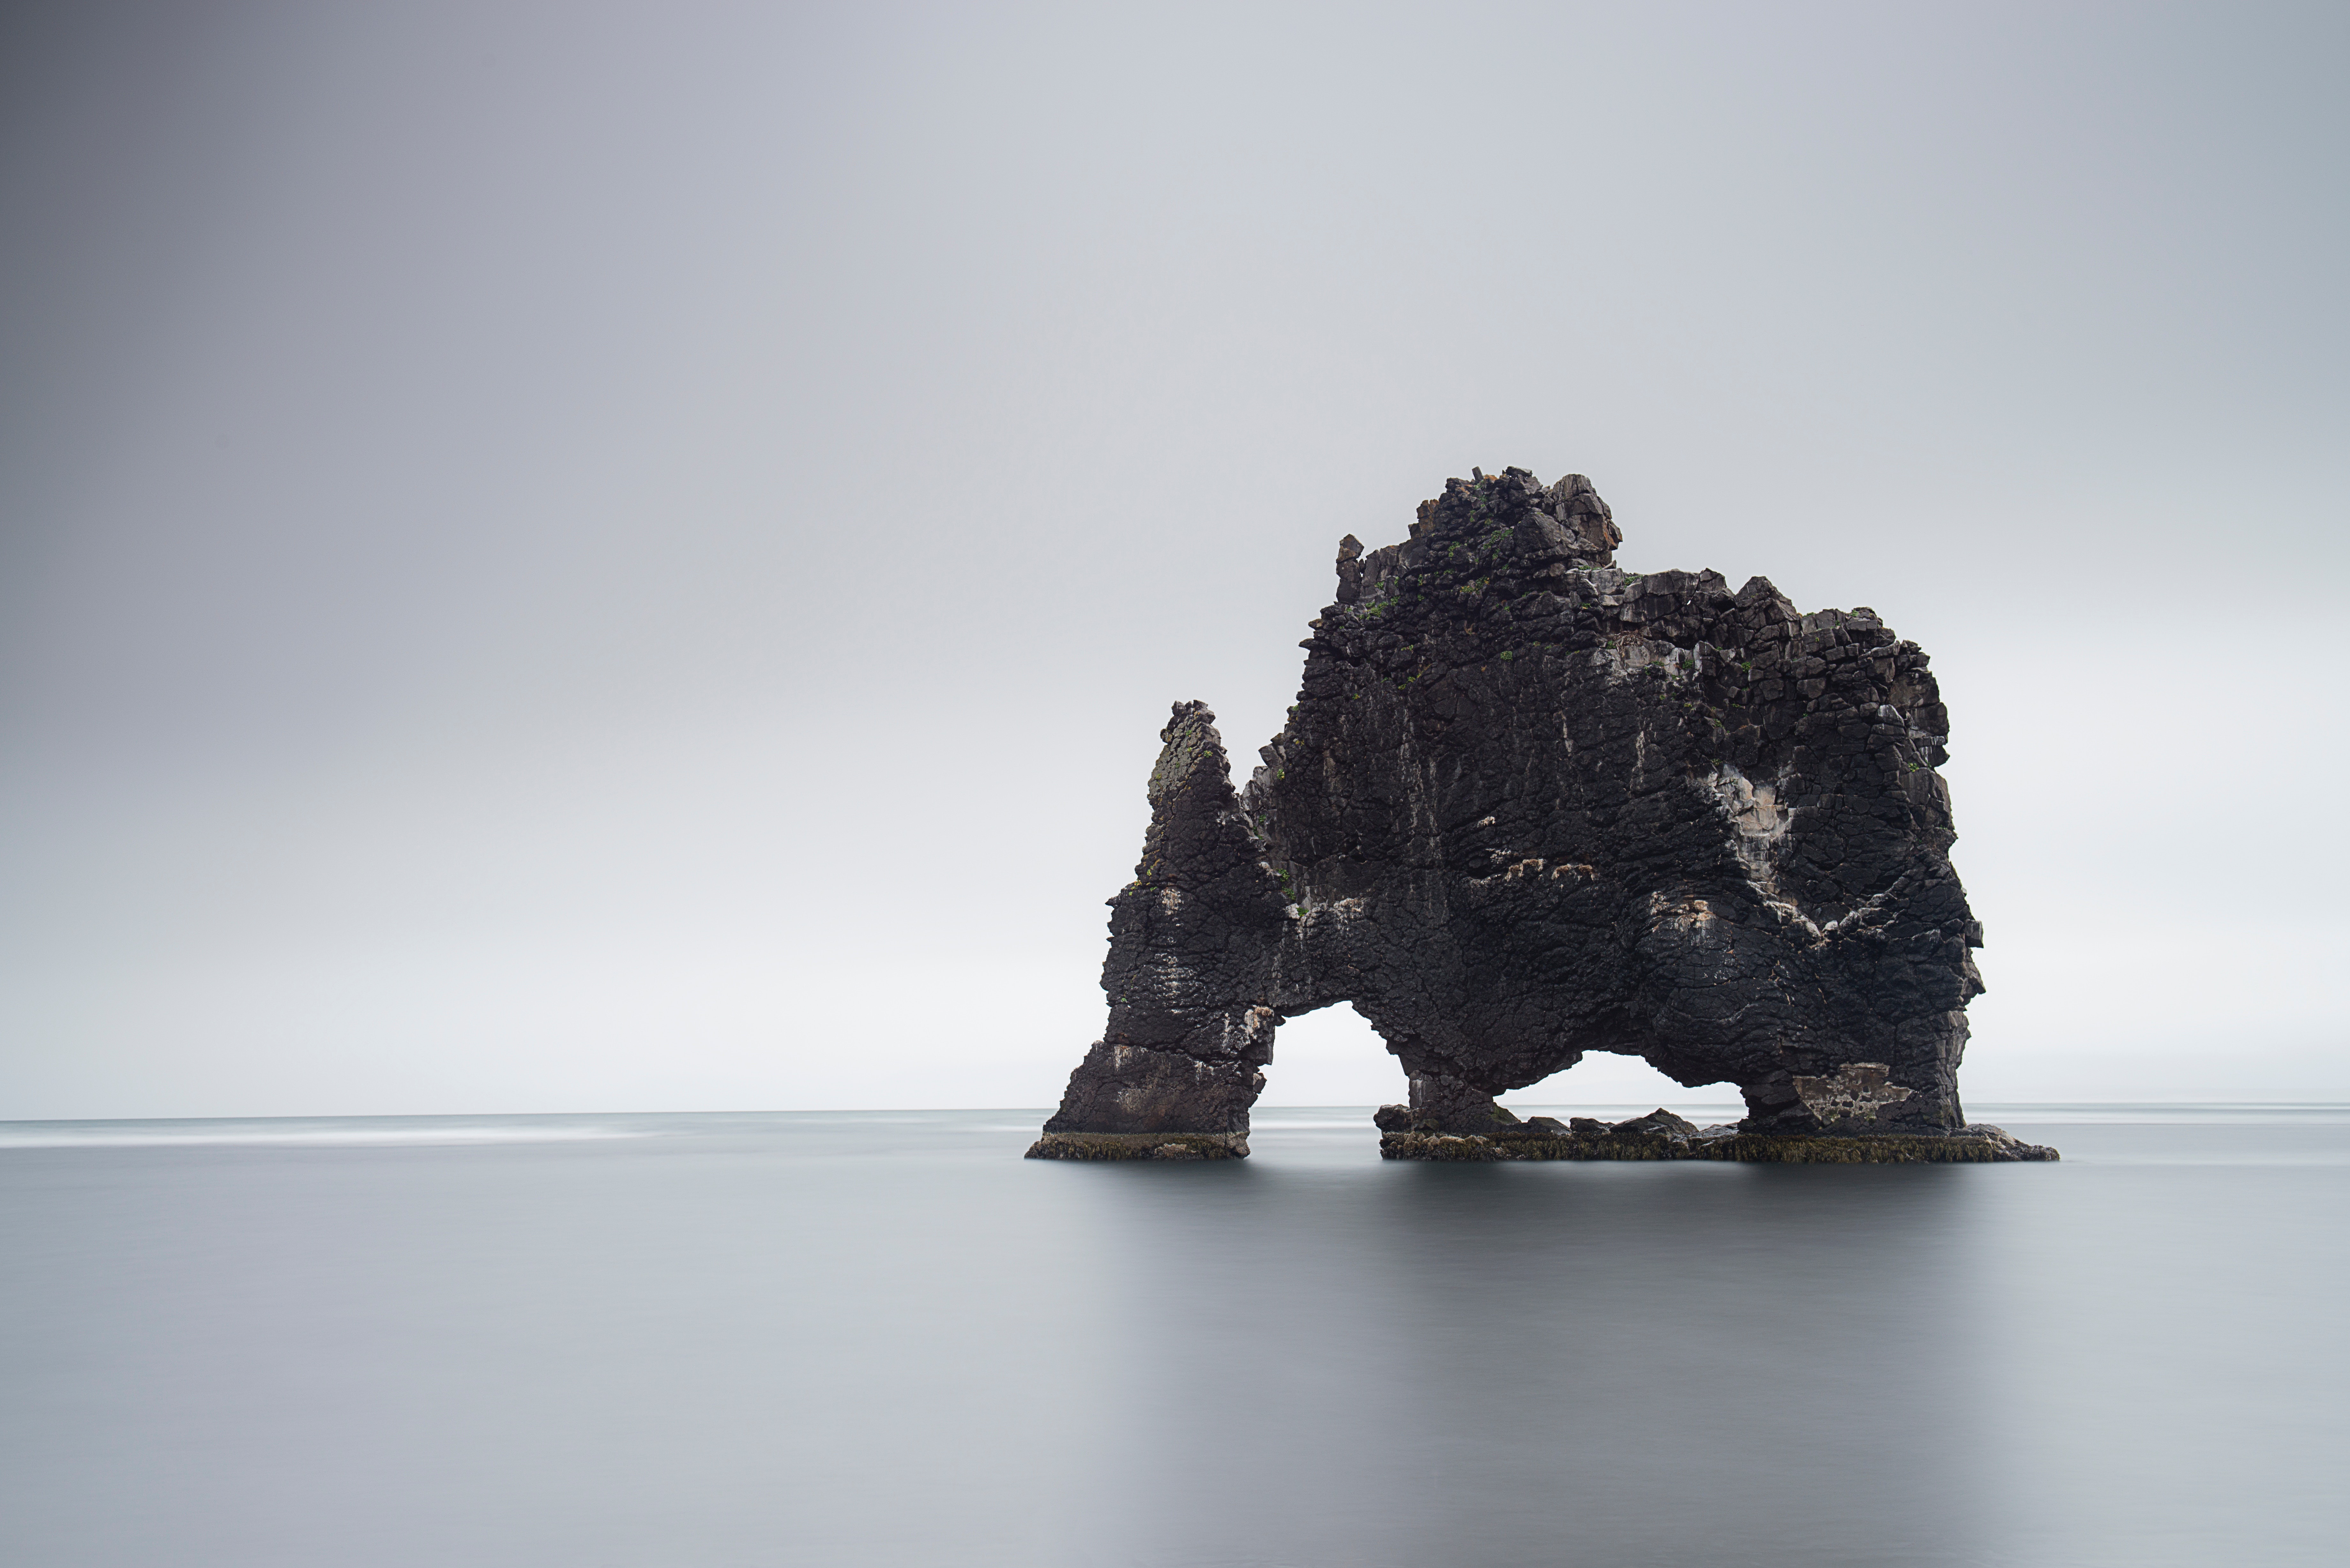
[0, 1105, 2350, 1568]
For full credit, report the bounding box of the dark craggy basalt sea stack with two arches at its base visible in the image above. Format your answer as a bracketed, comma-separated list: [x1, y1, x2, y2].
[1029, 468, 2054, 1161]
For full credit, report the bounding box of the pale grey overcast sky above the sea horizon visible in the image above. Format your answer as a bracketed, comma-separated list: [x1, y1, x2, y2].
[0, 0, 2350, 1117]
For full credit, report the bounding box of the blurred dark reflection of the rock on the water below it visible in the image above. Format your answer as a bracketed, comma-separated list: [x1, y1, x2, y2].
[1083, 1161, 1998, 1568]
